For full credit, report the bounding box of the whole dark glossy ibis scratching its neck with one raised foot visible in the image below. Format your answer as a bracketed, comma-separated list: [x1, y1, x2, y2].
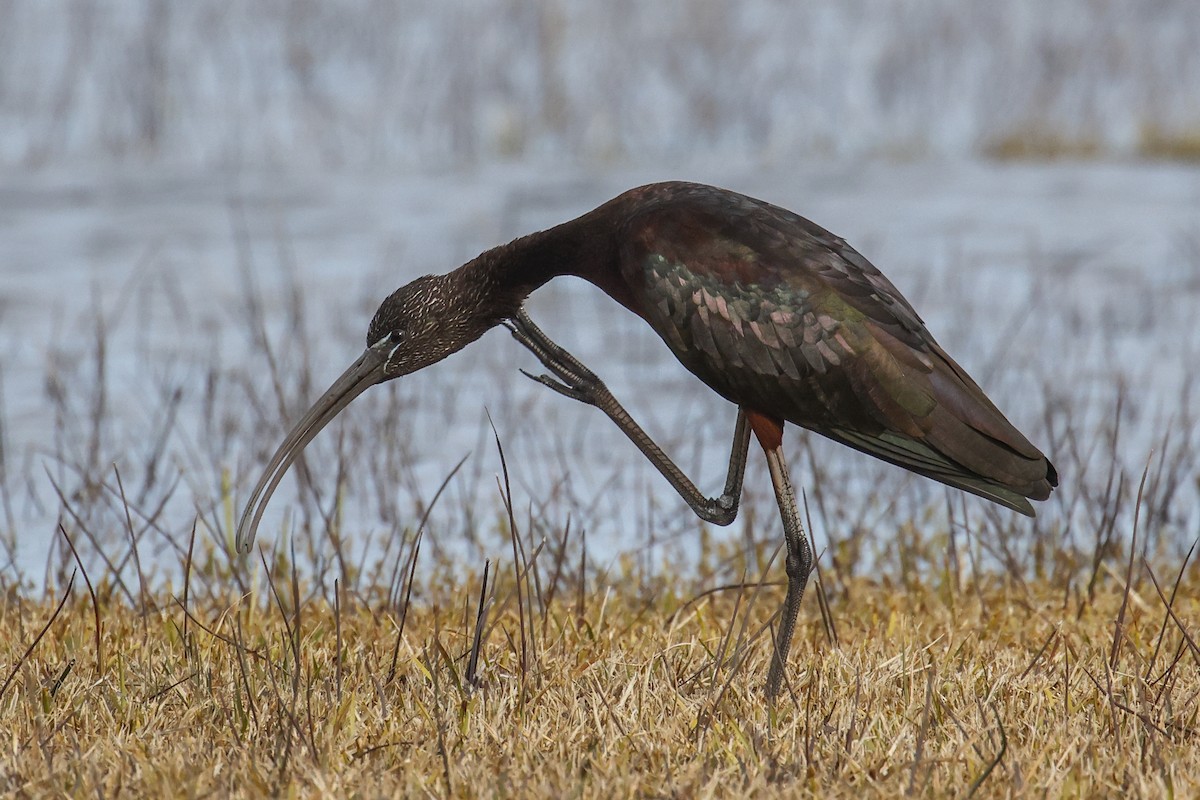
[236, 182, 1058, 698]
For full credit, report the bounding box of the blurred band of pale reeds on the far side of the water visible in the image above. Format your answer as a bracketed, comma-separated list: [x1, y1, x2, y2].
[0, 0, 1200, 168]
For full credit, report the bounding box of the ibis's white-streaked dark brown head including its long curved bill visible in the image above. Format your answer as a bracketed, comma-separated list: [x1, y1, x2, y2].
[236, 272, 501, 553]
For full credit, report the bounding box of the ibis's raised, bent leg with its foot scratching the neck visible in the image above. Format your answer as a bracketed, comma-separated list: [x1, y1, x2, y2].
[505, 308, 750, 525]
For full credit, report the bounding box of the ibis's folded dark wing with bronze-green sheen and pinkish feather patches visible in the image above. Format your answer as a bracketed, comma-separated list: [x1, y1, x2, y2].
[619, 185, 1054, 513]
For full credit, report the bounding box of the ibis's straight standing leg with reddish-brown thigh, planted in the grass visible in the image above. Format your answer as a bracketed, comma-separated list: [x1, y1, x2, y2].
[748, 413, 812, 700]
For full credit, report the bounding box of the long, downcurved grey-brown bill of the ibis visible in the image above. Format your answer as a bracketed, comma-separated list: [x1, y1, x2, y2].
[236, 349, 385, 553]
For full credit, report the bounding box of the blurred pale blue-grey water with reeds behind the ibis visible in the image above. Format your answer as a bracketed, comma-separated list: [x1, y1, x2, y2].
[0, 0, 1200, 583]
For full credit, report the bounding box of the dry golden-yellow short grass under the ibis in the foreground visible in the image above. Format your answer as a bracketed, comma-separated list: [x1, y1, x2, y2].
[0, 532, 1200, 798]
